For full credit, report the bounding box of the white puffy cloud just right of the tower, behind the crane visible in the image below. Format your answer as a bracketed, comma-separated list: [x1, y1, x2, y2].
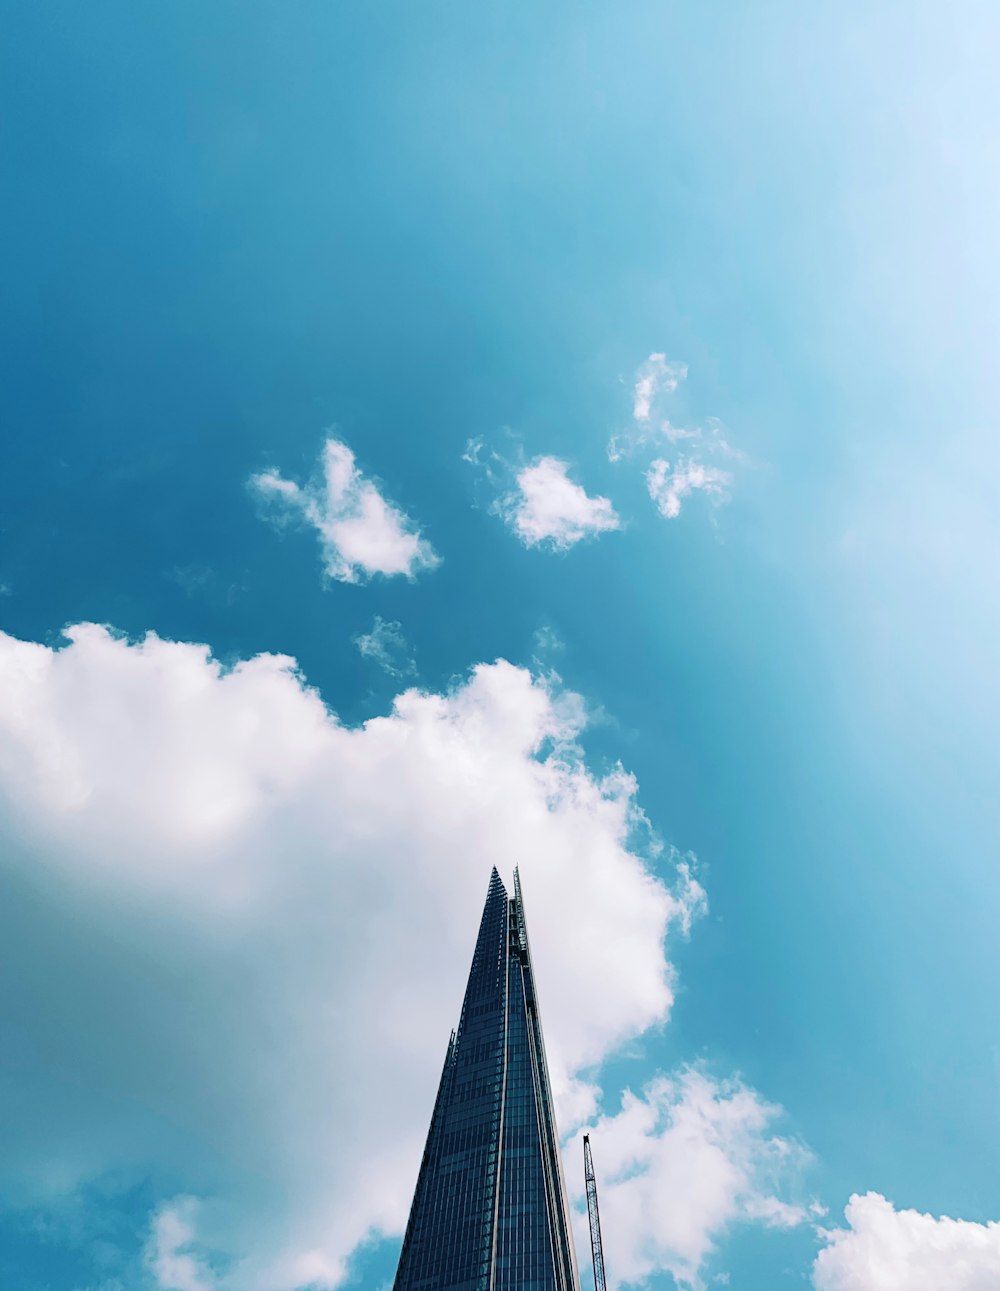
[578, 1068, 809, 1288]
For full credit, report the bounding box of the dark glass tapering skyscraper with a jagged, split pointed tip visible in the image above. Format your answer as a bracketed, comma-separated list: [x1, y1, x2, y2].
[395, 869, 578, 1291]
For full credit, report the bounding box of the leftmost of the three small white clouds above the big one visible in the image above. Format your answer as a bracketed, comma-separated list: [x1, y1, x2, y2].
[249, 439, 440, 582]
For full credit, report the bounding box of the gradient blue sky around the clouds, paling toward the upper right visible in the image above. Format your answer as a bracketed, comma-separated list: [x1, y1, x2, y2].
[0, 0, 1000, 1291]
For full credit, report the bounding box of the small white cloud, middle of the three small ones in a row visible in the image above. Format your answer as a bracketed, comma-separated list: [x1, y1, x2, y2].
[497, 457, 621, 551]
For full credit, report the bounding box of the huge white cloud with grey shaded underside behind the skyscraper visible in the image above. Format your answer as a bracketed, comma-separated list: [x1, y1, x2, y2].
[0, 626, 712, 1291]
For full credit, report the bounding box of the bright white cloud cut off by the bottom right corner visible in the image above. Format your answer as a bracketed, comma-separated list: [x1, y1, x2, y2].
[813, 1193, 1000, 1291]
